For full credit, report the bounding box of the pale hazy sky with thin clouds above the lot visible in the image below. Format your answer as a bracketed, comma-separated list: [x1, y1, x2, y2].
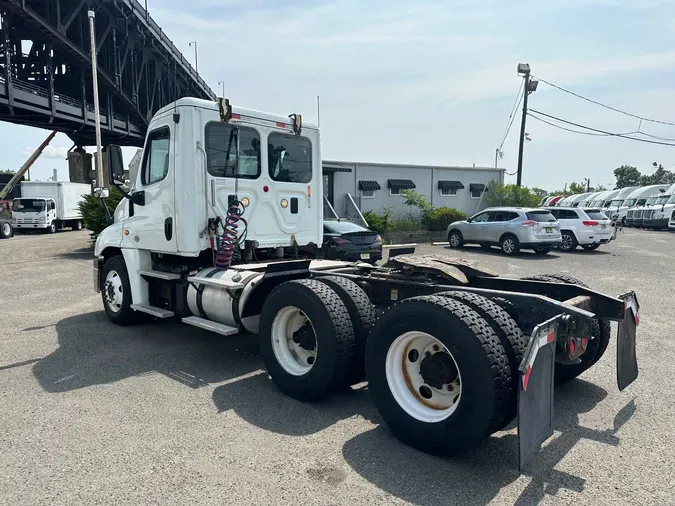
[0, 0, 675, 190]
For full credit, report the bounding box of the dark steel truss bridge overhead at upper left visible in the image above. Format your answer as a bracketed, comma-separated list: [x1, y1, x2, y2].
[0, 0, 216, 146]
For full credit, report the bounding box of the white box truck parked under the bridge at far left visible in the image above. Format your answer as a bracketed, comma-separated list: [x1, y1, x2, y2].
[12, 181, 91, 234]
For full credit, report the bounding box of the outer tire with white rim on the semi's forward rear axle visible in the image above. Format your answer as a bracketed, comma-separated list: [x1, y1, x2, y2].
[260, 280, 355, 401]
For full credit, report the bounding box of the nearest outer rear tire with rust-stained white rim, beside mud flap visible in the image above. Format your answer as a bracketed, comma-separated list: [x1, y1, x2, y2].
[366, 295, 512, 455]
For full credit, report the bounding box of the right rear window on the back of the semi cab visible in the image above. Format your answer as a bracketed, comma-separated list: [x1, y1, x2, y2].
[267, 132, 312, 183]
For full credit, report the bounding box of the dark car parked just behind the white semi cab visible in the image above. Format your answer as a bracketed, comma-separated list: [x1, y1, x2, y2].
[323, 221, 382, 263]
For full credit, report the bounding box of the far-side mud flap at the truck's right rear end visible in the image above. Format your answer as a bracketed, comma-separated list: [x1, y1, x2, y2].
[616, 292, 640, 391]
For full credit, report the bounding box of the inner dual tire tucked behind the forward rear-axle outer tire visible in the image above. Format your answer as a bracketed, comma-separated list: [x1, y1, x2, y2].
[317, 276, 377, 385]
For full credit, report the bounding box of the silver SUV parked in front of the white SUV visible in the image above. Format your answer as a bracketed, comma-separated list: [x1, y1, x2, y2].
[448, 207, 562, 255]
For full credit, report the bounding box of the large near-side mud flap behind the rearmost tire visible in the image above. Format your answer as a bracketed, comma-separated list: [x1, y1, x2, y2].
[518, 315, 562, 471]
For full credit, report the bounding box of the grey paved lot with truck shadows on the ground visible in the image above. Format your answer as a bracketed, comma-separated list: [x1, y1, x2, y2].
[0, 230, 675, 505]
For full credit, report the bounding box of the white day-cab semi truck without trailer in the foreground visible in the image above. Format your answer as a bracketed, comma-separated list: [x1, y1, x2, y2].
[93, 98, 639, 467]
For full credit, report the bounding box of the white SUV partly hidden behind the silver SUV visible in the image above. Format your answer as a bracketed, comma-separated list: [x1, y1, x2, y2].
[545, 207, 613, 251]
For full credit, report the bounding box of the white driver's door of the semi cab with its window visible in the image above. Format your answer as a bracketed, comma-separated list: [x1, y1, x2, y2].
[122, 119, 176, 253]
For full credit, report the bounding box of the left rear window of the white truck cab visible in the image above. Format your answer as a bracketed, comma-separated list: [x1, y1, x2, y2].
[205, 121, 261, 179]
